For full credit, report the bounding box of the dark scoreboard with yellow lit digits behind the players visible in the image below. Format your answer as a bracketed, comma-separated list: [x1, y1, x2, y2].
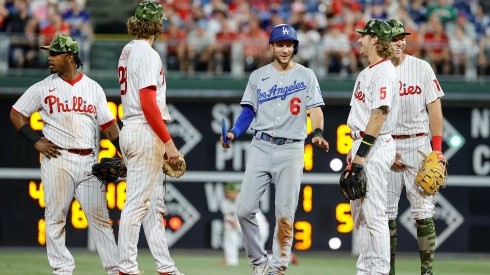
[0, 98, 490, 252]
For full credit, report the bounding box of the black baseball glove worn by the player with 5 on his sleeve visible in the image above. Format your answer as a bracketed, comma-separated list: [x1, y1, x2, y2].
[339, 163, 367, 200]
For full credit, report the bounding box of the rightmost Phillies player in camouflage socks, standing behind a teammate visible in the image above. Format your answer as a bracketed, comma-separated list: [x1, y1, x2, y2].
[387, 19, 444, 274]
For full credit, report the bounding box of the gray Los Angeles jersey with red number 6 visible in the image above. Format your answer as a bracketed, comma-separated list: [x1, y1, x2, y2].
[240, 63, 325, 139]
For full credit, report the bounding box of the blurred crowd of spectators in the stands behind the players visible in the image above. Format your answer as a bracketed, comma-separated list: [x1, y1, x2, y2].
[0, 0, 490, 80]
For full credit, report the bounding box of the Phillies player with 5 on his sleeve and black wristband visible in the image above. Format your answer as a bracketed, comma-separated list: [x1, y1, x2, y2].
[347, 19, 398, 274]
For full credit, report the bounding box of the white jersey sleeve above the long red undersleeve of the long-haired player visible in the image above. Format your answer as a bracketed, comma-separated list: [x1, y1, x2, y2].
[135, 48, 162, 90]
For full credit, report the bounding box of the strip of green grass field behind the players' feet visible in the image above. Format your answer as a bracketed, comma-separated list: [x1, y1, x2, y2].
[0, 248, 490, 275]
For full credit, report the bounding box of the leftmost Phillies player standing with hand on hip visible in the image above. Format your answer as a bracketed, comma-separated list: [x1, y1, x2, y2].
[10, 35, 119, 274]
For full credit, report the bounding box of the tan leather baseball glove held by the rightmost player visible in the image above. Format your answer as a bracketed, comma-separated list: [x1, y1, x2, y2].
[415, 151, 447, 195]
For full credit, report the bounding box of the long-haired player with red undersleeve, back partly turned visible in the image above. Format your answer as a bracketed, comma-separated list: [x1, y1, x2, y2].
[118, 1, 181, 275]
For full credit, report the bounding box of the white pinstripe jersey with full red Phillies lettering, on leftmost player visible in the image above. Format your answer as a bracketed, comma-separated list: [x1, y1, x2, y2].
[13, 73, 114, 149]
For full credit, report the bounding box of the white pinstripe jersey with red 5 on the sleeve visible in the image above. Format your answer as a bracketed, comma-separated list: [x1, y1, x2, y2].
[347, 59, 399, 134]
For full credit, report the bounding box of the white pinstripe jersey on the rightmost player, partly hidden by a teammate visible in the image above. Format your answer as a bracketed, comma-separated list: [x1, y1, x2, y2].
[393, 55, 444, 135]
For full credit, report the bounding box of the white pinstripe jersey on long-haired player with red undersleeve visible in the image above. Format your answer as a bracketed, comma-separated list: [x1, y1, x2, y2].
[118, 40, 170, 125]
